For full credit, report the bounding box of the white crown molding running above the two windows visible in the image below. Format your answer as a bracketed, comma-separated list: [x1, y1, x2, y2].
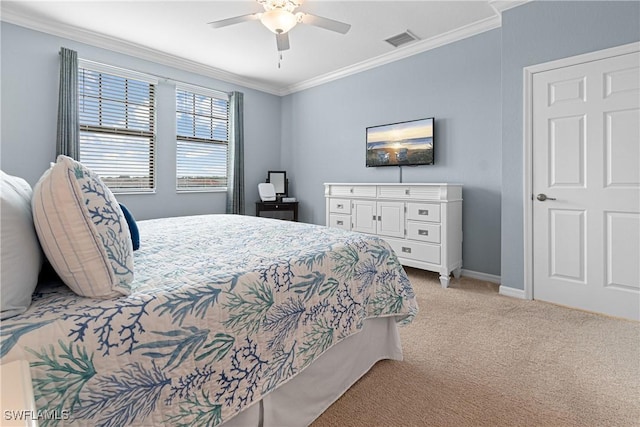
[0, 3, 282, 96]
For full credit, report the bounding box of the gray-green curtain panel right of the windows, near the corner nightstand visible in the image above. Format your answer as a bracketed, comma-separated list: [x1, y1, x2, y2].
[227, 92, 244, 215]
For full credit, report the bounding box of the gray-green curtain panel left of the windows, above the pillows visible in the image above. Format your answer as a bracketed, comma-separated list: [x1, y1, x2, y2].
[56, 47, 80, 160]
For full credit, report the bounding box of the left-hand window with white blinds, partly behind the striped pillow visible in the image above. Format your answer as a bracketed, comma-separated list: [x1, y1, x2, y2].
[78, 61, 156, 193]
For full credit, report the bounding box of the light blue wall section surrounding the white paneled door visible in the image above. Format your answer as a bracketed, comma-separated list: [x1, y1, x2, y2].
[501, 1, 640, 289]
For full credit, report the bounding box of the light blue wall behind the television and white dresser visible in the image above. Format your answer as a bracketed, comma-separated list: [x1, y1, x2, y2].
[282, 30, 502, 275]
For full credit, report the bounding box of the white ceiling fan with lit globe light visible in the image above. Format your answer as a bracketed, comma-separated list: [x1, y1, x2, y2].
[209, 0, 351, 52]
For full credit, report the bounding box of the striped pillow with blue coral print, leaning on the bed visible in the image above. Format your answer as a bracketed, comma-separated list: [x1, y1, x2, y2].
[32, 156, 133, 298]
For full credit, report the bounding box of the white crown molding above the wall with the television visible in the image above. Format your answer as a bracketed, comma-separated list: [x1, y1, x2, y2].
[281, 14, 502, 95]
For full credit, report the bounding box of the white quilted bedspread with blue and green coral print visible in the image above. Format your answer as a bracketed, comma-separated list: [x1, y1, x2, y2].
[0, 215, 418, 426]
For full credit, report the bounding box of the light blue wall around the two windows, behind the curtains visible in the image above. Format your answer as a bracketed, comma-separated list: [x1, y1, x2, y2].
[0, 22, 281, 219]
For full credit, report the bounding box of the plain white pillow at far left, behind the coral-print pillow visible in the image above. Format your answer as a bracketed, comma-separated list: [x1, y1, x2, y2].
[0, 171, 42, 319]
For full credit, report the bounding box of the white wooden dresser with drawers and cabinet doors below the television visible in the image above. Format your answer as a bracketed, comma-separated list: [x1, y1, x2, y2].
[324, 183, 462, 288]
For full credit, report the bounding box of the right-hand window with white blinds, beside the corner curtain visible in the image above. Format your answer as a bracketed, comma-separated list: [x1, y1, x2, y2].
[176, 85, 229, 191]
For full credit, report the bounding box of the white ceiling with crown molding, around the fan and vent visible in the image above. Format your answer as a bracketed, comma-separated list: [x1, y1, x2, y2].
[0, 0, 524, 95]
